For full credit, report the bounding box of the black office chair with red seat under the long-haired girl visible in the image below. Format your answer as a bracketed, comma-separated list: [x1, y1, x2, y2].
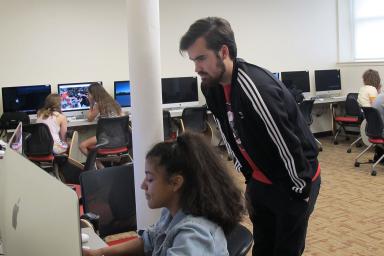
[84, 115, 132, 170]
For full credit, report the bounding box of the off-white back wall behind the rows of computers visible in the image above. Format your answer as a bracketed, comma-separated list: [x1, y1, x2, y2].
[0, 0, 383, 131]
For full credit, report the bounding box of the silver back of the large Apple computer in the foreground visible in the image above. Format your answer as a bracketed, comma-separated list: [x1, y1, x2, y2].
[0, 145, 82, 256]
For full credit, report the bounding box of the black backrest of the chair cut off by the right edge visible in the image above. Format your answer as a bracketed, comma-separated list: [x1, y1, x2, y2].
[363, 107, 384, 138]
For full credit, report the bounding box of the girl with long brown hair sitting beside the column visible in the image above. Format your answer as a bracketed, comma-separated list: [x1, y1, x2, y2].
[79, 82, 123, 157]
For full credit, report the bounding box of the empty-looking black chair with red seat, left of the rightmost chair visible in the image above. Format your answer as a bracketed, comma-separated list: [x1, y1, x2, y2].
[333, 93, 364, 153]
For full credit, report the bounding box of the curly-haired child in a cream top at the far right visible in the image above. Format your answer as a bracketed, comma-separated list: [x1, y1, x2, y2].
[357, 69, 381, 107]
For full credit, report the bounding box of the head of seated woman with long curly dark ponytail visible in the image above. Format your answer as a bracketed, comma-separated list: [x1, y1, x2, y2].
[142, 133, 244, 232]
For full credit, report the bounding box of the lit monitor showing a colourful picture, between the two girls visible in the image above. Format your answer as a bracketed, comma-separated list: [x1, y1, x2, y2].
[57, 82, 92, 111]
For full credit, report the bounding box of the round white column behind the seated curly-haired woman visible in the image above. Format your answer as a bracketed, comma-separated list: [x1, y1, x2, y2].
[127, 0, 163, 229]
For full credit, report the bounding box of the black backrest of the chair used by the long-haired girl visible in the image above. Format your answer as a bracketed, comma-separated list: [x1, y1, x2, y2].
[96, 115, 132, 148]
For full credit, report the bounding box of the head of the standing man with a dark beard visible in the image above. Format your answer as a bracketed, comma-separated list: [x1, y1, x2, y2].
[179, 17, 237, 85]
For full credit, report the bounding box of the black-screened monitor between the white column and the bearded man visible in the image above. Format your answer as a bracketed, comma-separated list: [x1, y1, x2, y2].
[161, 77, 199, 108]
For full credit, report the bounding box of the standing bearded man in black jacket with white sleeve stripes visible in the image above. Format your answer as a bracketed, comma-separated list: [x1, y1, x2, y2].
[180, 17, 320, 256]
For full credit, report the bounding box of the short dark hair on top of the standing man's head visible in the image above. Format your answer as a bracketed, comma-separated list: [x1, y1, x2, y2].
[179, 17, 237, 60]
